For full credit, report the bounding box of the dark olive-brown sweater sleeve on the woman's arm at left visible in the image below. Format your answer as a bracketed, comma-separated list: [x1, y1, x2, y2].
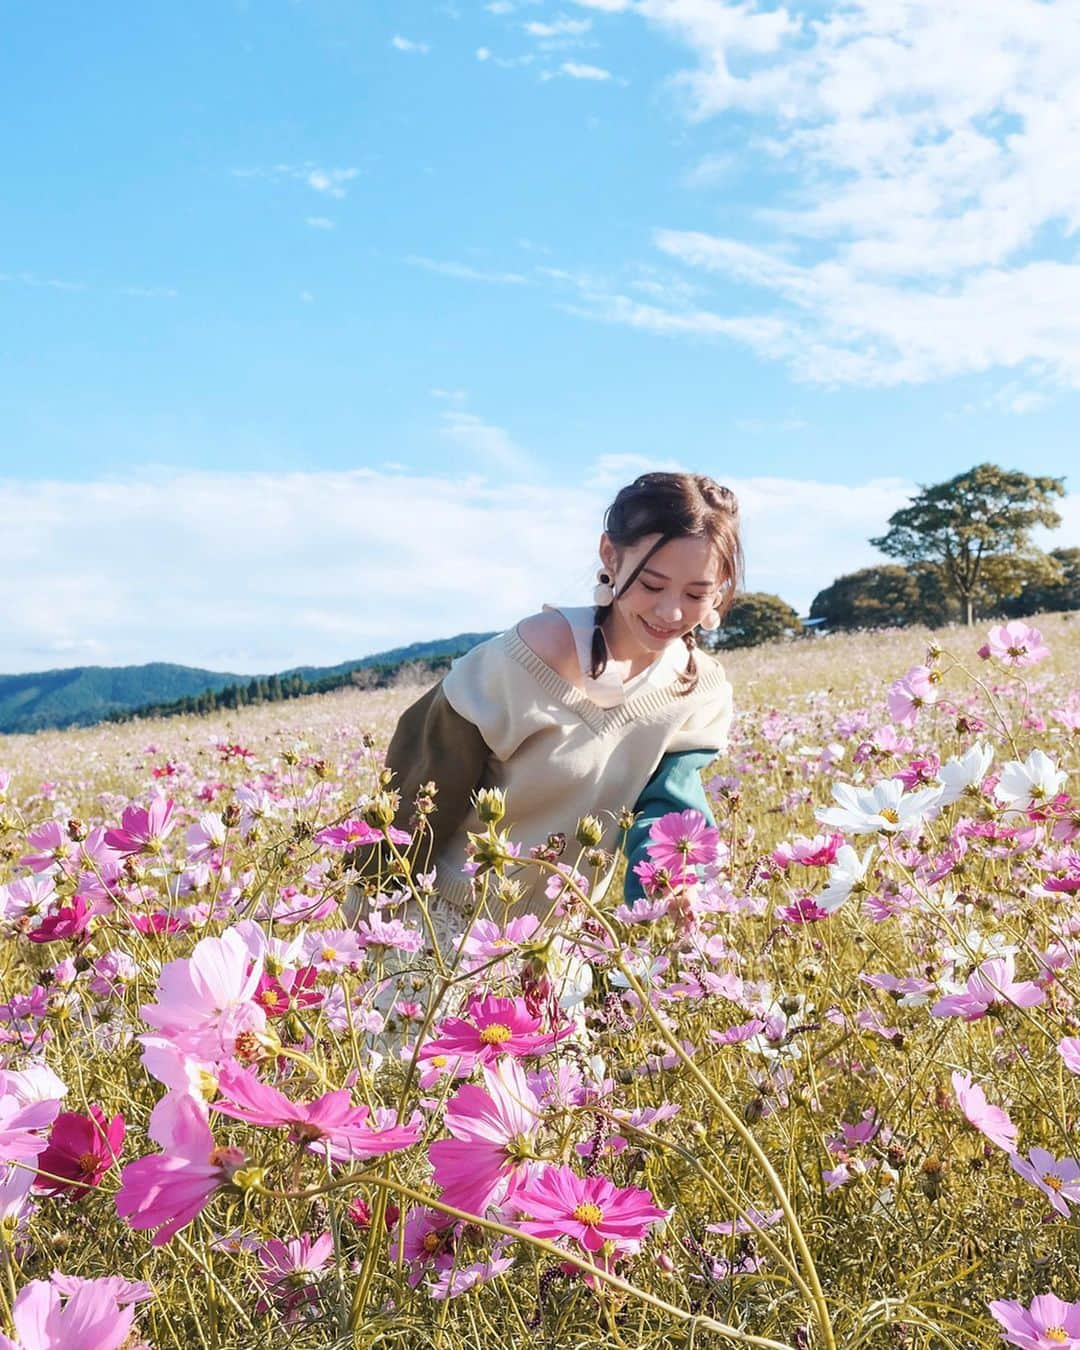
[371, 682, 490, 863]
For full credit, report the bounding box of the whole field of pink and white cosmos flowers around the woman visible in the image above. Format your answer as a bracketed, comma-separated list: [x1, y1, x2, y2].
[0, 614, 1080, 1350]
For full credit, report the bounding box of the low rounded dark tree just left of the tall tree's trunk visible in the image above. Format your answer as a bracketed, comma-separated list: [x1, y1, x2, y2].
[810, 563, 959, 629]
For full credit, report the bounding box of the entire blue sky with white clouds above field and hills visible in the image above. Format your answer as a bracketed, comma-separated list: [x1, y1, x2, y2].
[0, 0, 1080, 671]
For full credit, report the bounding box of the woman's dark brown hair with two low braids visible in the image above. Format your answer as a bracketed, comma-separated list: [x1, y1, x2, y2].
[591, 474, 743, 694]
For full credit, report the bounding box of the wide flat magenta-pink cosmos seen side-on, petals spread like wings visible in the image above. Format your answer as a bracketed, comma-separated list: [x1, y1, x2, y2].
[213, 1064, 420, 1158]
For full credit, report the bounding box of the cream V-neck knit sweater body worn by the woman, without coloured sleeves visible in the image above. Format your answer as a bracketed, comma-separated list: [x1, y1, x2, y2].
[435, 628, 732, 917]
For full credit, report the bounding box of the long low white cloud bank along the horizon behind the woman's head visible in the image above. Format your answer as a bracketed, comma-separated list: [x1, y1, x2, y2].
[0, 467, 1080, 674]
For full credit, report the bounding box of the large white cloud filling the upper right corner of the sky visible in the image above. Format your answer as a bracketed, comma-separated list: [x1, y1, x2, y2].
[553, 0, 1080, 394]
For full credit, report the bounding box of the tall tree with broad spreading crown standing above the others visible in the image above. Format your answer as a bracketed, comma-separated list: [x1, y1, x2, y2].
[871, 464, 1065, 625]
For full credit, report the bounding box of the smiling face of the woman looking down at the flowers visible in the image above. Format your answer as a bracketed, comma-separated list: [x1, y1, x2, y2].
[599, 533, 721, 653]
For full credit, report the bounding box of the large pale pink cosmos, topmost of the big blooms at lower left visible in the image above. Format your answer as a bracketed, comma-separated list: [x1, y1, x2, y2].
[140, 929, 266, 1060]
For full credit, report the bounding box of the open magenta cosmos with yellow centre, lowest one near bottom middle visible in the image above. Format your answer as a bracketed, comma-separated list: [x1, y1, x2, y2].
[514, 1166, 667, 1254]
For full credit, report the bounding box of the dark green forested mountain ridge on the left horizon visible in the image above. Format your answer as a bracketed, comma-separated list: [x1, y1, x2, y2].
[0, 633, 493, 733]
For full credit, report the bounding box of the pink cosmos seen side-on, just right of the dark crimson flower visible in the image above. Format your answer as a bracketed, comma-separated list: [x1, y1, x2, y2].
[116, 1098, 246, 1247]
